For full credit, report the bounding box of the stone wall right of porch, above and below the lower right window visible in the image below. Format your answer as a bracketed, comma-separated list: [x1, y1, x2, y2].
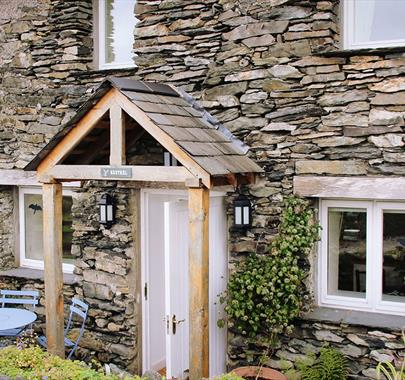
[135, 0, 405, 378]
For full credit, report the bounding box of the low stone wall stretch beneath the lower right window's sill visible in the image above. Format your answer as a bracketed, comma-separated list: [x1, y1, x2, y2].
[229, 321, 405, 379]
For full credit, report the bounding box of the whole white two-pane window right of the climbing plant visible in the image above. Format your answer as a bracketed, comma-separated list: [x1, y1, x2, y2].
[319, 200, 405, 315]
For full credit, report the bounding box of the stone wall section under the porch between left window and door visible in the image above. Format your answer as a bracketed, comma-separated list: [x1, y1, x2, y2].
[72, 182, 139, 371]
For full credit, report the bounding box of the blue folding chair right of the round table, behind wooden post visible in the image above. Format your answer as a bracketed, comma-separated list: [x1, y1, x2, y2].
[38, 298, 89, 359]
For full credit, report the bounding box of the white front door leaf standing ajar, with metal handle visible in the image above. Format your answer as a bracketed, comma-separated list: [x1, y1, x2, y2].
[164, 200, 189, 379]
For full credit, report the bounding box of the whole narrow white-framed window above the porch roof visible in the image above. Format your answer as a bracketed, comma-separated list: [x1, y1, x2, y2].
[95, 0, 138, 69]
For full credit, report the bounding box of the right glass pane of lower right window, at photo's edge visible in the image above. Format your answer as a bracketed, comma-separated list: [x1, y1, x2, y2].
[383, 210, 405, 302]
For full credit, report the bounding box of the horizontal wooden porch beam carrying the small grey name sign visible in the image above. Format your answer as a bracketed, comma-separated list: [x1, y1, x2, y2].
[39, 165, 197, 183]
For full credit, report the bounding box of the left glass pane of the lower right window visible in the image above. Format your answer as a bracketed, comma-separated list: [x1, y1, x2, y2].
[328, 208, 367, 298]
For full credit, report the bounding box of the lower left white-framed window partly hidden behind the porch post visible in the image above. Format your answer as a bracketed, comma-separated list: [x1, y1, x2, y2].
[19, 188, 74, 272]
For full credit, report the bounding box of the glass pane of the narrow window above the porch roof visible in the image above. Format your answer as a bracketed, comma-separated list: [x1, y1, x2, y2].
[105, 0, 138, 64]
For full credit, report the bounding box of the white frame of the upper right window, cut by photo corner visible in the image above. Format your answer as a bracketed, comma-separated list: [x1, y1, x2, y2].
[341, 0, 405, 50]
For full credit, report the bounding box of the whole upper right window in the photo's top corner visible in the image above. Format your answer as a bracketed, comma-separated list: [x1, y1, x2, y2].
[343, 0, 405, 49]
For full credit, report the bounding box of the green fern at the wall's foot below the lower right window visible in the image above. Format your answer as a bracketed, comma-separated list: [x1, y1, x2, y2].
[297, 347, 348, 380]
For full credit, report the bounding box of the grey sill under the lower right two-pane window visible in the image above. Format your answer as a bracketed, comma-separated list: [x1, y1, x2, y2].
[303, 307, 404, 331]
